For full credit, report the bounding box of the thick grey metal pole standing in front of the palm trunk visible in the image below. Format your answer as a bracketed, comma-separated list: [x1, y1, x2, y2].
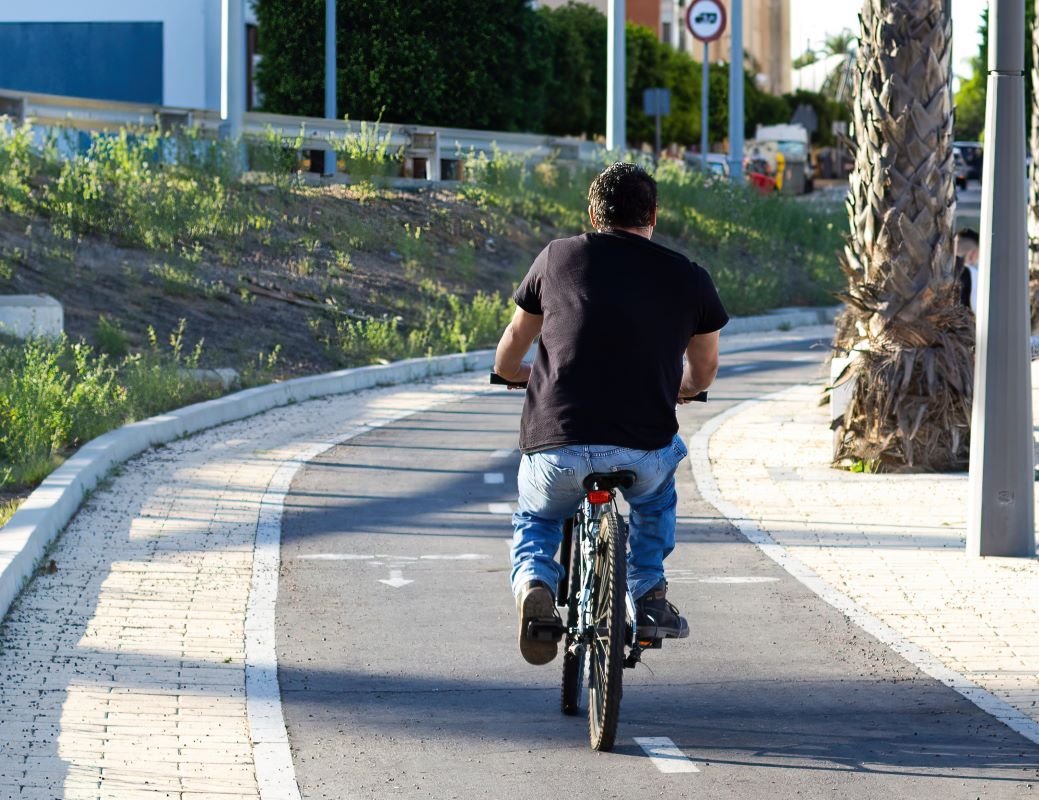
[967, 0, 1035, 557]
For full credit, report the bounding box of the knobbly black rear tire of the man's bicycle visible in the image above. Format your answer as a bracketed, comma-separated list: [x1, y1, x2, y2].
[588, 511, 628, 750]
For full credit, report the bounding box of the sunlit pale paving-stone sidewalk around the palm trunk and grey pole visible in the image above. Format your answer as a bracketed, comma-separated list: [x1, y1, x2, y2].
[709, 377, 1039, 735]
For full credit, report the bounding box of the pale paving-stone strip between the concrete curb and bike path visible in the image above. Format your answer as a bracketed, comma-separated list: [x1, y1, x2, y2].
[0, 374, 485, 800]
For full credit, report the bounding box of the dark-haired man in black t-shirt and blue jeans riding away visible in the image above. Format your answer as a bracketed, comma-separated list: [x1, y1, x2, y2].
[495, 162, 728, 664]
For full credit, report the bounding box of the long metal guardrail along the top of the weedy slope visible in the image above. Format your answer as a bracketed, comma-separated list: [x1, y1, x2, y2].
[0, 89, 604, 181]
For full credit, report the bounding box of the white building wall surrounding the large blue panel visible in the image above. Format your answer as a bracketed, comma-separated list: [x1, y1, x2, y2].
[0, 0, 256, 110]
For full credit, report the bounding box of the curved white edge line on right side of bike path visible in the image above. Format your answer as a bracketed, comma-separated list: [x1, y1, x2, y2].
[689, 385, 1039, 744]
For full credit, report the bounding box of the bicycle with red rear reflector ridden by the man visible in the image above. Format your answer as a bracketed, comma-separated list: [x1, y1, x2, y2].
[490, 373, 708, 751]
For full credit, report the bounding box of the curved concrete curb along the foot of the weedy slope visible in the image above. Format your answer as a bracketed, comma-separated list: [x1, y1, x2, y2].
[0, 306, 840, 618]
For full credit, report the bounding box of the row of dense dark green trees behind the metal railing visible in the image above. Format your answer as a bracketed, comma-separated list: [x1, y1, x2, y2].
[256, 0, 831, 144]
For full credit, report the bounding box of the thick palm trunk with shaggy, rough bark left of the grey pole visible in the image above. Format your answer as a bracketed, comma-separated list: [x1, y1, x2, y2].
[834, 0, 974, 471]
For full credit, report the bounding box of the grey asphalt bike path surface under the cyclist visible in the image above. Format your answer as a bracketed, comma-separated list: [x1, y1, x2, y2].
[277, 328, 1039, 800]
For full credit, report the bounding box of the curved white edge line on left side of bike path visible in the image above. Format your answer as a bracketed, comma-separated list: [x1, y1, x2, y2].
[245, 395, 482, 800]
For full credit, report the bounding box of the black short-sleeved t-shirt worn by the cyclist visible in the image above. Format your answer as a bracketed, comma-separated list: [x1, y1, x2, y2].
[513, 231, 728, 453]
